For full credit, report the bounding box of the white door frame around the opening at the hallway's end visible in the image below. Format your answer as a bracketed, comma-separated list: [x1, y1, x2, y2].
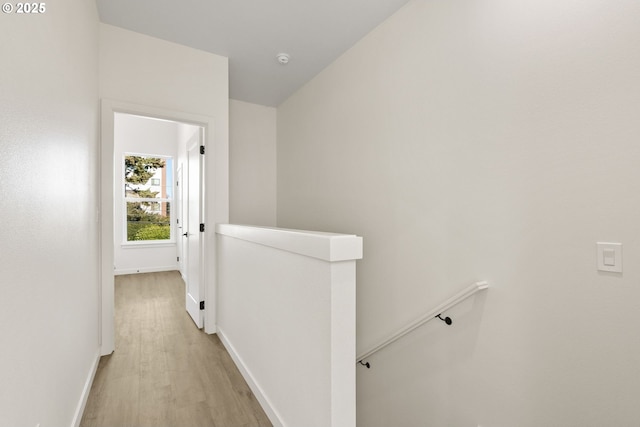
[98, 99, 229, 355]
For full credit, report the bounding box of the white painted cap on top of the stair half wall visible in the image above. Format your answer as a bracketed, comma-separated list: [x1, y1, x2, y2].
[216, 224, 362, 262]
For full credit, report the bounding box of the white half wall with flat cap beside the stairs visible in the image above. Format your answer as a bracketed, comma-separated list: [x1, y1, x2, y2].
[217, 224, 362, 427]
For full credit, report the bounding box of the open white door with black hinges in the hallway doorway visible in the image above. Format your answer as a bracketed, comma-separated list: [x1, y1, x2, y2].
[183, 136, 204, 328]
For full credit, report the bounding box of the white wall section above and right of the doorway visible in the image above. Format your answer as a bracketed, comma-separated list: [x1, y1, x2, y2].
[100, 24, 229, 332]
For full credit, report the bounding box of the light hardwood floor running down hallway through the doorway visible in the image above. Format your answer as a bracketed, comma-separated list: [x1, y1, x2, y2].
[81, 272, 271, 427]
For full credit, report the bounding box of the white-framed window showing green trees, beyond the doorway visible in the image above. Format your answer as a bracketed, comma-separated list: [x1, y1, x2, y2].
[124, 154, 173, 242]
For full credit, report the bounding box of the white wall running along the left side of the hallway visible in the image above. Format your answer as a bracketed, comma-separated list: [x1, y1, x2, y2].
[0, 0, 99, 427]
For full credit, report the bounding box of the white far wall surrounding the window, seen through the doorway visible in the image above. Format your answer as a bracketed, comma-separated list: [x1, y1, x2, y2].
[113, 114, 180, 274]
